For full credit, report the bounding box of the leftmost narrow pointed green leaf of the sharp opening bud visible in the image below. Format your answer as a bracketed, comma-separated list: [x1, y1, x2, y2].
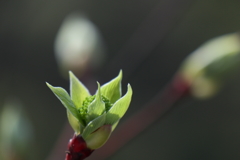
[46, 83, 83, 124]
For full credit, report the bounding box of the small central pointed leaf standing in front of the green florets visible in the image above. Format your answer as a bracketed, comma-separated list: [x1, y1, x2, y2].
[87, 82, 105, 123]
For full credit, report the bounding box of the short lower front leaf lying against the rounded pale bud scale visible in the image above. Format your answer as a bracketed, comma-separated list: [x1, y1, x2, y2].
[82, 113, 106, 139]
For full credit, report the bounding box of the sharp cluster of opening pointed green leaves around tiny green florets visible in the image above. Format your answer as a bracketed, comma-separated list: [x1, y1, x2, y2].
[47, 71, 132, 144]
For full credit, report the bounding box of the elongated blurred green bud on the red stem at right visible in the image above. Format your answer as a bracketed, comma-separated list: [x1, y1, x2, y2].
[178, 33, 240, 98]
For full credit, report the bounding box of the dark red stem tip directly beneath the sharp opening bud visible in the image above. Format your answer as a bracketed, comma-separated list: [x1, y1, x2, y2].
[65, 134, 94, 160]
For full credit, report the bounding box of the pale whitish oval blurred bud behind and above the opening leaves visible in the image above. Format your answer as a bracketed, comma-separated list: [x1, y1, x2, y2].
[55, 13, 105, 77]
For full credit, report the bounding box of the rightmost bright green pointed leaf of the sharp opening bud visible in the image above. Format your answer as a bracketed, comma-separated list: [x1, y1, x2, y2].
[105, 84, 132, 125]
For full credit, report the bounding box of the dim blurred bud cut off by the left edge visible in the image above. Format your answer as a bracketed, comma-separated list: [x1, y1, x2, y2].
[0, 100, 34, 160]
